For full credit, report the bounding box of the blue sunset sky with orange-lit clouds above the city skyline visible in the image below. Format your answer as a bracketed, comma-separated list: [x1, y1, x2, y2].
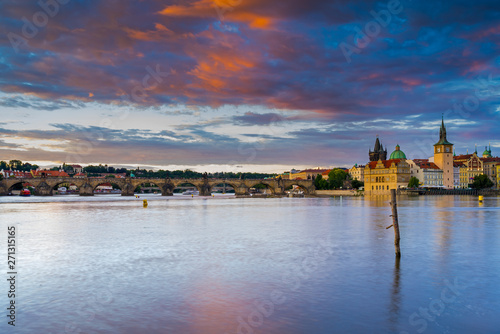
[0, 0, 500, 172]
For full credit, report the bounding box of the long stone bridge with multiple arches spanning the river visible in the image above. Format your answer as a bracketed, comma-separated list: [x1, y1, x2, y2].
[0, 177, 315, 196]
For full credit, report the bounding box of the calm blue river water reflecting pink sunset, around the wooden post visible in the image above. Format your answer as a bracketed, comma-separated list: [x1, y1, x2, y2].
[0, 195, 500, 334]
